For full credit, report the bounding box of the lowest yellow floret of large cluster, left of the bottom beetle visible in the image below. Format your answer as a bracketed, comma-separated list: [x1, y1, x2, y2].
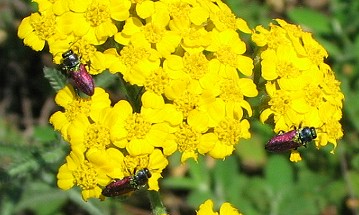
[57, 148, 123, 201]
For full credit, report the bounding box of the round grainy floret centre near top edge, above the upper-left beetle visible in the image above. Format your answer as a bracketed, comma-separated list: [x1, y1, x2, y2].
[85, 3, 111, 27]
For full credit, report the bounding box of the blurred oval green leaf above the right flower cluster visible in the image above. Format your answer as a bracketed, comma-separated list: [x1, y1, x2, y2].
[288, 8, 331, 34]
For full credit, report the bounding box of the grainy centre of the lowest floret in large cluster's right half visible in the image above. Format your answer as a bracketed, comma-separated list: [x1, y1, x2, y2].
[175, 124, 201, 152]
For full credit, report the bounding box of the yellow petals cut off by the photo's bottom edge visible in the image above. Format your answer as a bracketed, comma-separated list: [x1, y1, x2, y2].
[197, 199, 242, 215]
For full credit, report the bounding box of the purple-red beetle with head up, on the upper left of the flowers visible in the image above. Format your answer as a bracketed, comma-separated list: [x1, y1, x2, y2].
[62, 50, 95, 96]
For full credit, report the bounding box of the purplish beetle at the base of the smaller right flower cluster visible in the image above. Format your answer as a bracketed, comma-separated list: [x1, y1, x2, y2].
[265, 127, 317, 152]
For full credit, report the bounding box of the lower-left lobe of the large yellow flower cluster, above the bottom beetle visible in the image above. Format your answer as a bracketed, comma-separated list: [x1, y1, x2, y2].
[50, 86, 168, 200]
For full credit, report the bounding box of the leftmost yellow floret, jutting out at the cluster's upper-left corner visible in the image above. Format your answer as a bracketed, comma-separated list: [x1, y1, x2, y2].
[17, 11, 56, 51]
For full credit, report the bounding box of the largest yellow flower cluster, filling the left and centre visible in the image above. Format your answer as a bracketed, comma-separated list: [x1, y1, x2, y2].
[18, 0, 258, 200]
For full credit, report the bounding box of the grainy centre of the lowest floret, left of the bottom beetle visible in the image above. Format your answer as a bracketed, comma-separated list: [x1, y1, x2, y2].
[73, 160, 98, 190]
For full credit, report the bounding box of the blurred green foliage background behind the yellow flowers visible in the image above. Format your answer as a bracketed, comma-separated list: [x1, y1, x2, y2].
[0, 0, 359, 215]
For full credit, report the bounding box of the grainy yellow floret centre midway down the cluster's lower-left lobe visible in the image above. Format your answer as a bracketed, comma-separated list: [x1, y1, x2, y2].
[84, 124, 111, 149]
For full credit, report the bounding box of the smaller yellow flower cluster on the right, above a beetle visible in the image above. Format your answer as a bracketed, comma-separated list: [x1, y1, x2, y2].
[252, 19, 344, 161]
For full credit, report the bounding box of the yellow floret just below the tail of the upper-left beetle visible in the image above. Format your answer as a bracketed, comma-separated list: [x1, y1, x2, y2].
[49, 86, 111, 140]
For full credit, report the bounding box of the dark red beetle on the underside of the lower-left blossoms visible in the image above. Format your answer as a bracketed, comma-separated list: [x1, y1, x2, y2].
[102, 168, 152, 197]
